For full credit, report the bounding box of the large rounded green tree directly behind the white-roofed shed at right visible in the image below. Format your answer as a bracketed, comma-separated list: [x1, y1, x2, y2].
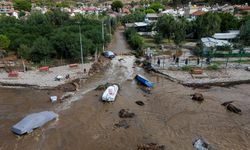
[195, 12, 221, 38]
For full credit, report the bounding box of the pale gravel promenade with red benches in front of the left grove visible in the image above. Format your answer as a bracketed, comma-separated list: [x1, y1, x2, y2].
[0, 63, 92, 89]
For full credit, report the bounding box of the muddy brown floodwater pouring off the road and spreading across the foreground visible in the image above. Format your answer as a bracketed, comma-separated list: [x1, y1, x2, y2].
[0, 28, 250, 150]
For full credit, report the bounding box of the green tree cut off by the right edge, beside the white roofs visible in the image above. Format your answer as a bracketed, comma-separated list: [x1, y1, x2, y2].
[240, 20, 250, 46]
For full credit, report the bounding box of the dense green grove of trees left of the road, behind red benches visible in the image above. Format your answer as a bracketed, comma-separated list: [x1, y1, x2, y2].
[0, 10, 112, 63]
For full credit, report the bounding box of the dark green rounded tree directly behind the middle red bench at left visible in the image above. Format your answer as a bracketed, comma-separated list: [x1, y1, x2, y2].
[31, 37, 54, 63]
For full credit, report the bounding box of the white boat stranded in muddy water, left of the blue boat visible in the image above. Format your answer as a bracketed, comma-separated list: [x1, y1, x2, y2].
[102, 85, 119, 102]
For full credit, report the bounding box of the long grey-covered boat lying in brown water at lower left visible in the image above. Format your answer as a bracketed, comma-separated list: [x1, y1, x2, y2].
[11, 111, 58, 135]
